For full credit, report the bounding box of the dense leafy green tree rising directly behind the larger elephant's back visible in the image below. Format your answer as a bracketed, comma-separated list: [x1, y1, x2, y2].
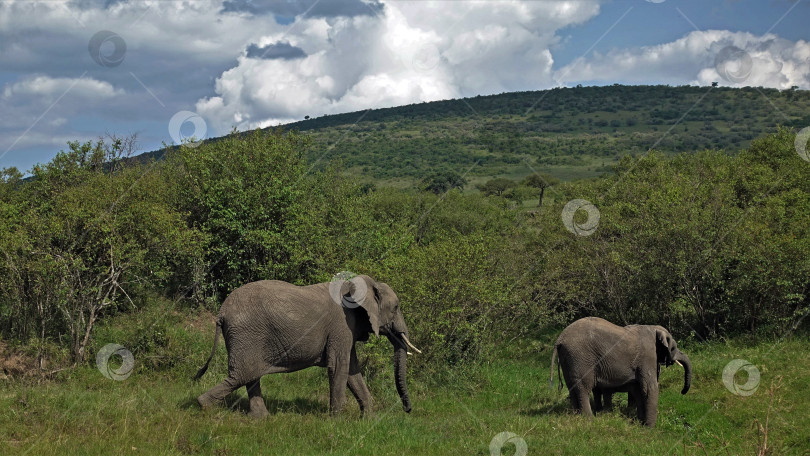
[169, 130, 308, 298]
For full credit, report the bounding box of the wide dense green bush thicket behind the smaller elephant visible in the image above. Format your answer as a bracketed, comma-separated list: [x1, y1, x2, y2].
[536, 130, 810, 337]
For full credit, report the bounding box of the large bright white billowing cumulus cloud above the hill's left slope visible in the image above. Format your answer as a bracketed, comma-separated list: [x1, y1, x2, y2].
[196, 0, 599, 132]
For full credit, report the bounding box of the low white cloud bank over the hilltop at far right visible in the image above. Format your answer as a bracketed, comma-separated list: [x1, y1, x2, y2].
[554, 30, 810, 89]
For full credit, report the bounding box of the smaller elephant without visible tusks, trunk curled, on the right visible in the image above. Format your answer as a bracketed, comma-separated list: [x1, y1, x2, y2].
[550, 317, 692, 427]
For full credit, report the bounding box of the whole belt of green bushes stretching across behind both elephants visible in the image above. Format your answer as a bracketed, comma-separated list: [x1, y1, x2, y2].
[0, 125, 810, 375]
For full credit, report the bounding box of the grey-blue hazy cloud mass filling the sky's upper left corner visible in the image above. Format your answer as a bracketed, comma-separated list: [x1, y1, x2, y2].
[0, 0, 287, 169]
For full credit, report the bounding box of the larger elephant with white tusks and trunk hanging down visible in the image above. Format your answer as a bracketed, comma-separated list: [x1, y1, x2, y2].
[195, 275, 421, 417]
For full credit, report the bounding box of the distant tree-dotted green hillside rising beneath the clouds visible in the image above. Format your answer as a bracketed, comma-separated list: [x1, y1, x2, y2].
[284, 85, 810, 185]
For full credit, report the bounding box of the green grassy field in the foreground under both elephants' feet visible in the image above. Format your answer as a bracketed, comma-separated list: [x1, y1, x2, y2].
[0, 306, 810, 455]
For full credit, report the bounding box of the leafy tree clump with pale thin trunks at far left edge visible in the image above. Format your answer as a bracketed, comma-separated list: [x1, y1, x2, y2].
[0, 137, 198, 363]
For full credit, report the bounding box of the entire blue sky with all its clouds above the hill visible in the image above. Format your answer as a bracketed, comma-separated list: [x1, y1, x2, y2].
[0, 0, 810, 170]
